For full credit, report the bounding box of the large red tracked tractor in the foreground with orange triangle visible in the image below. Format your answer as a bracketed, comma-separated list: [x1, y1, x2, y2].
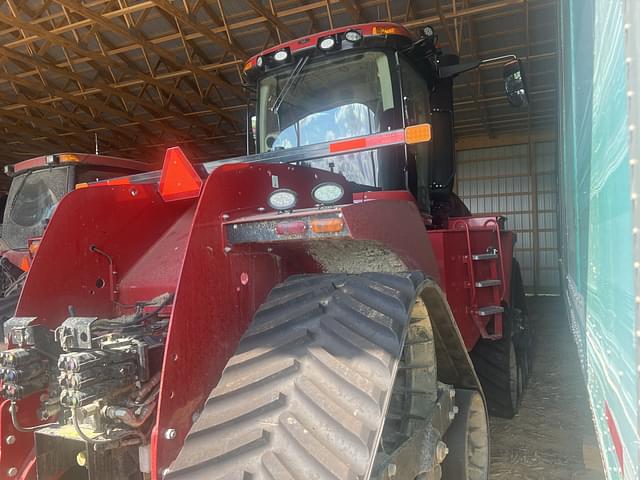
[0, 23, 529, 480]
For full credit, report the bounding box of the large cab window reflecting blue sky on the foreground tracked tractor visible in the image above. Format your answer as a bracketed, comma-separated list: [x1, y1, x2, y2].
[257, 51, 394, 187]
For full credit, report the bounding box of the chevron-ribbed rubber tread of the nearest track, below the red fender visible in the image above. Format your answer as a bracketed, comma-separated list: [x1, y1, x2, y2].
[164, 273, 423, 480]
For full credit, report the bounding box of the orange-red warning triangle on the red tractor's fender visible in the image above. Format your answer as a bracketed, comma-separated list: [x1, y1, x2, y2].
[160, 147, 202, 202]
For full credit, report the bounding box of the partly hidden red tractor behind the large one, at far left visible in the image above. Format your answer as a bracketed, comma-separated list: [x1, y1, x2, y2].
[0, 153, 151, 324]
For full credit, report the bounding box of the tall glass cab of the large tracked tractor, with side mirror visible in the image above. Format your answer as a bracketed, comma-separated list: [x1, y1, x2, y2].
[244, 22, 526, 221]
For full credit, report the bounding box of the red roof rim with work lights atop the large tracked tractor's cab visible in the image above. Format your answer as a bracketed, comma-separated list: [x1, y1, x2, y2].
[243, 22, 414, 77]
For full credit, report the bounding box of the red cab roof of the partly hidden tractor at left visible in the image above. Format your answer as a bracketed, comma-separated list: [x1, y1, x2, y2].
[5, 153, 155, 175]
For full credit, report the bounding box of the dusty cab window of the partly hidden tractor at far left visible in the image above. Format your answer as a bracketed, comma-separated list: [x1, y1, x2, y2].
[2, 166, 70, 248]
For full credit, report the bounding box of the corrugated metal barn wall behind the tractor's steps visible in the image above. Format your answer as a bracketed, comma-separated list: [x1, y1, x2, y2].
[456, 141, 560, 294]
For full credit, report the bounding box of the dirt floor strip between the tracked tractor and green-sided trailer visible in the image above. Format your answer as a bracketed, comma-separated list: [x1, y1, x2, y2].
[491, 297, 604, 480]
